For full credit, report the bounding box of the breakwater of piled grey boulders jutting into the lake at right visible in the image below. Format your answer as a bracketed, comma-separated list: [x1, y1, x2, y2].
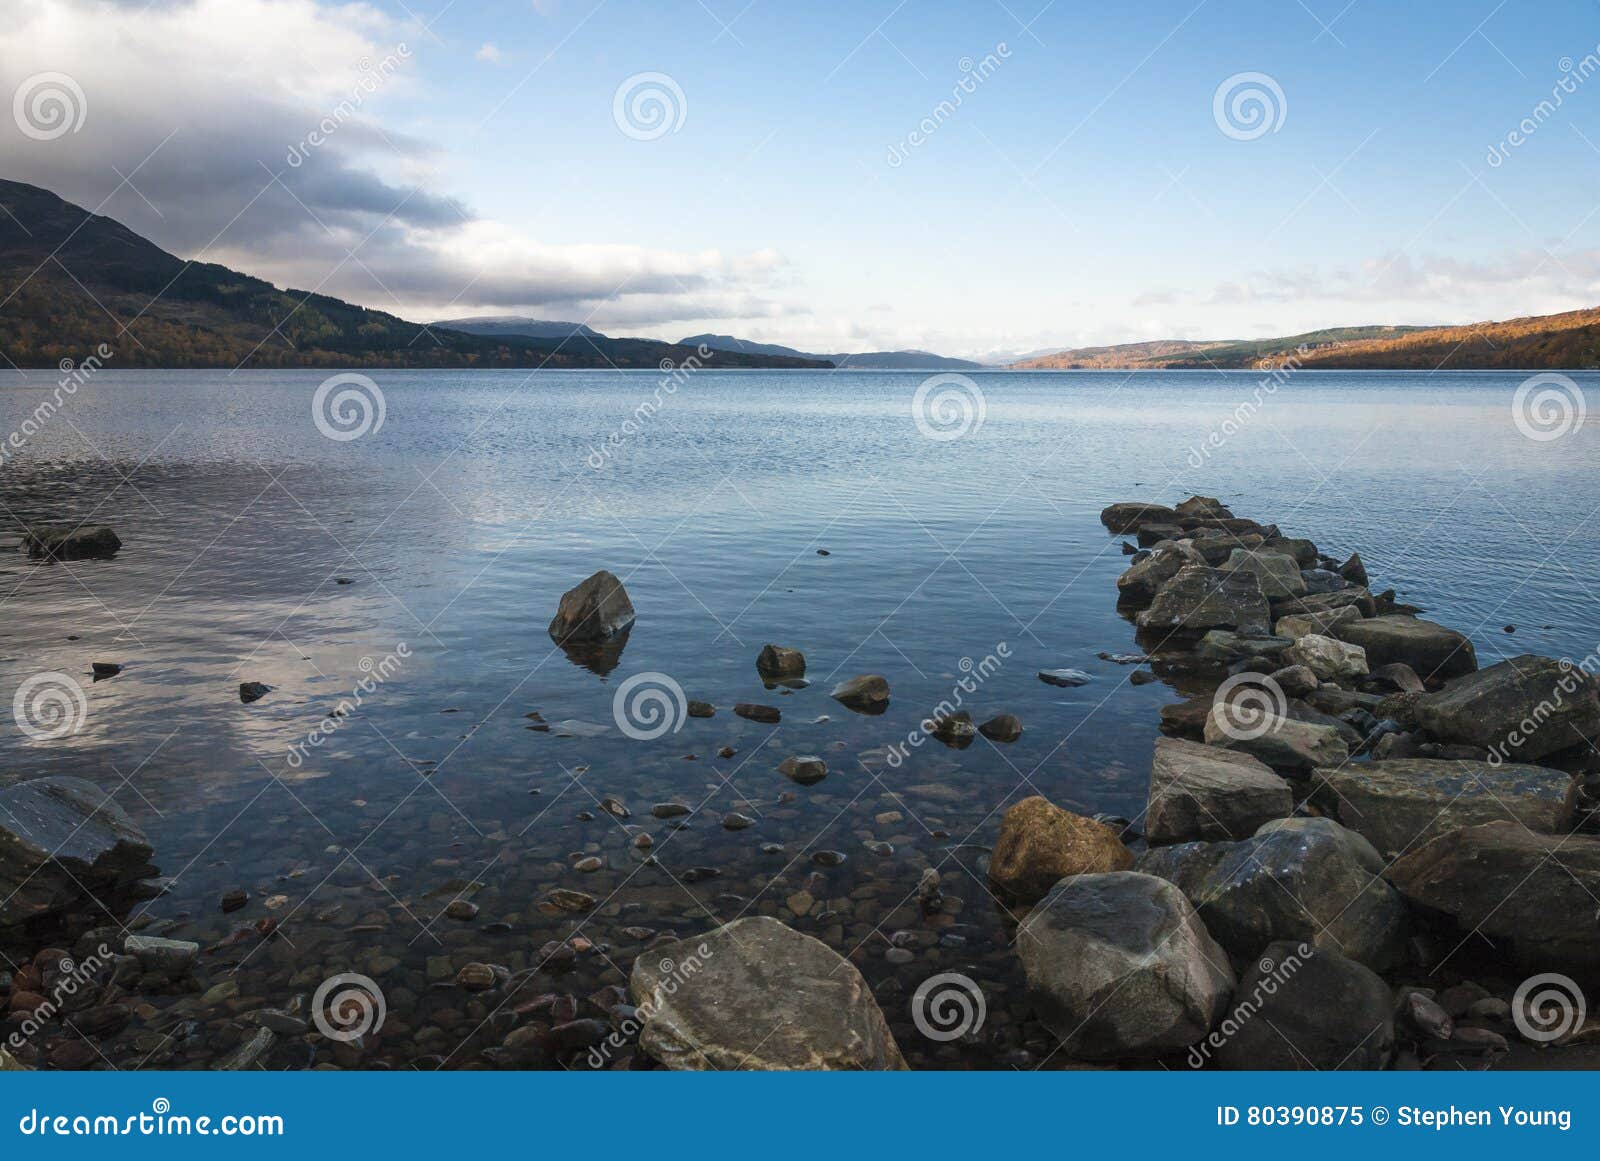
[1017, 496, 1600, 1068]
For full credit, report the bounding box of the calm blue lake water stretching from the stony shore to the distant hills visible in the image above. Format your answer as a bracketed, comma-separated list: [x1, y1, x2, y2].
[0, 371, 1600, 1068]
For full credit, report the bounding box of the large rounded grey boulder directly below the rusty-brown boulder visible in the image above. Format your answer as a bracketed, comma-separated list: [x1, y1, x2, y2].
[1016, 872, 1234, 1060]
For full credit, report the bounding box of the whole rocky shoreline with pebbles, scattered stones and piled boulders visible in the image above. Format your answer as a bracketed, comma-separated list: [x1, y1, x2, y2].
[0, 508, 1600, 1070]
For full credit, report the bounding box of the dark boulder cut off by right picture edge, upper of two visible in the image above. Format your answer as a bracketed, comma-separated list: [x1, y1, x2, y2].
[1414, 654, 1600, 761]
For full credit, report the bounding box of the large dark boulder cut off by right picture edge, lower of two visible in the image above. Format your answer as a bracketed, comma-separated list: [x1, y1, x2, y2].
[1387, 822, 1600, 982]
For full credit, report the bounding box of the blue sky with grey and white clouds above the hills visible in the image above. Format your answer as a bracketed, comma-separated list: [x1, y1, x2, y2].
[0, 0, 1600, 360]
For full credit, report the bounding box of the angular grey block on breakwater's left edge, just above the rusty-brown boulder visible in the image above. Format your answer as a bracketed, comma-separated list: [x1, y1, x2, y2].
[1144, 737, 1294, 846]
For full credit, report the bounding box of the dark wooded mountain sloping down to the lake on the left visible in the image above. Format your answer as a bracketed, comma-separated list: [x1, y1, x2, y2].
[0, 181, 827, 368]
